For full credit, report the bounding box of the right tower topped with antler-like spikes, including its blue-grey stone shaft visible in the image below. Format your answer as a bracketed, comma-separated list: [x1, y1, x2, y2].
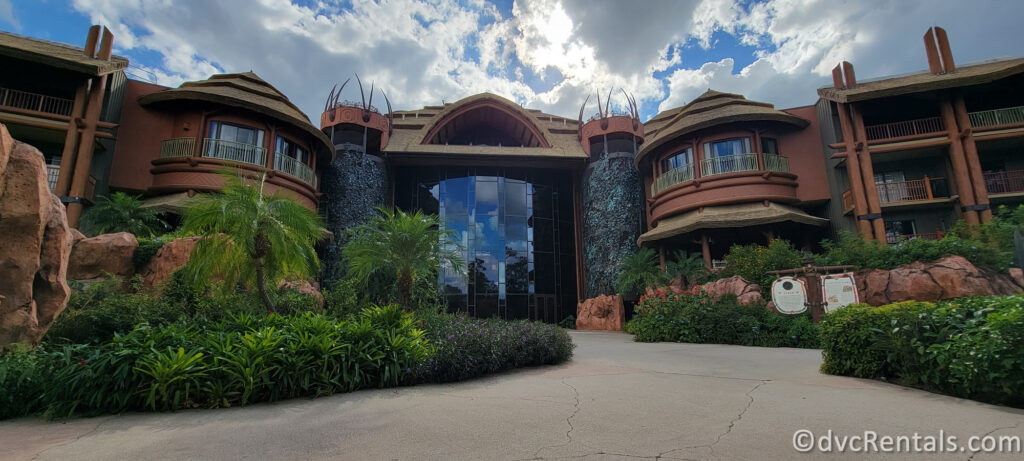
[578, 90, 644, 298]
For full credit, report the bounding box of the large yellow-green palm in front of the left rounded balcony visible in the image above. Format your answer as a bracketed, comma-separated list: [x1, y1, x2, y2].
[182, 173, 324, 311]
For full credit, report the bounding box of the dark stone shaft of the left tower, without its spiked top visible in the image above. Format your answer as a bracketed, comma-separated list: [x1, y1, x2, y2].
[321, 145, 388, 281]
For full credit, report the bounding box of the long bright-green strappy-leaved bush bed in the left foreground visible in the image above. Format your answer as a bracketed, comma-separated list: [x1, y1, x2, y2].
[0, 306, 431, 418]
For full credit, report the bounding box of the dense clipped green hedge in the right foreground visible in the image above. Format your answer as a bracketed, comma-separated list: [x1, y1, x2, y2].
[821, 296, 1024, 407]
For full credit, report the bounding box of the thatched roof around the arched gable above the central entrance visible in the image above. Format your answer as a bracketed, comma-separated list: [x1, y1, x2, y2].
[384, 93, 587, 159]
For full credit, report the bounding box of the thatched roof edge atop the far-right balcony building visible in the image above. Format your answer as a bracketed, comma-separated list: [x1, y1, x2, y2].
[818, 57, 1024, 102]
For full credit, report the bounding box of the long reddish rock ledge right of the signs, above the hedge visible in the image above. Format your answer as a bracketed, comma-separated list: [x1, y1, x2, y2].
[854, 256, 1024, 305]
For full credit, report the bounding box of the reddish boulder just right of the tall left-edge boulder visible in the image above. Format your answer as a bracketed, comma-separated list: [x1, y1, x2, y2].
[68, 233, 138, 280]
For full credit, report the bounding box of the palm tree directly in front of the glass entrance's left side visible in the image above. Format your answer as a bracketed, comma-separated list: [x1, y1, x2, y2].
[342, 208, 462, 309]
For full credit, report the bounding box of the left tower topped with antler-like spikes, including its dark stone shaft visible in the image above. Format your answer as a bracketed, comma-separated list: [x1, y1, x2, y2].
[321, 75, 392, 281]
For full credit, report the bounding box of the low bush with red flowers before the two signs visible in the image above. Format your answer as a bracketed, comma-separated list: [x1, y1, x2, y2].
[626, 290, 818, 348]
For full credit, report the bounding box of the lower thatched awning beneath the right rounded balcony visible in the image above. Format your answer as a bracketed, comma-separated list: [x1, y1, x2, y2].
[637, 202, 828, 245]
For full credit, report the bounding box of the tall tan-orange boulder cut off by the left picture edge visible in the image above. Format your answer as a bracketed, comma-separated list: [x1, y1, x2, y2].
[0, 125, 73, 348]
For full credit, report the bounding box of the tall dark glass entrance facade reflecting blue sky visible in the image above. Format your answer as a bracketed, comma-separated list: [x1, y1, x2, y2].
[394, 166, 577, 322]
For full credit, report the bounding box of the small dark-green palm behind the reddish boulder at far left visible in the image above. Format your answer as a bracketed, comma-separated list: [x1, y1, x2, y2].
[82, 192, 168, 237]
